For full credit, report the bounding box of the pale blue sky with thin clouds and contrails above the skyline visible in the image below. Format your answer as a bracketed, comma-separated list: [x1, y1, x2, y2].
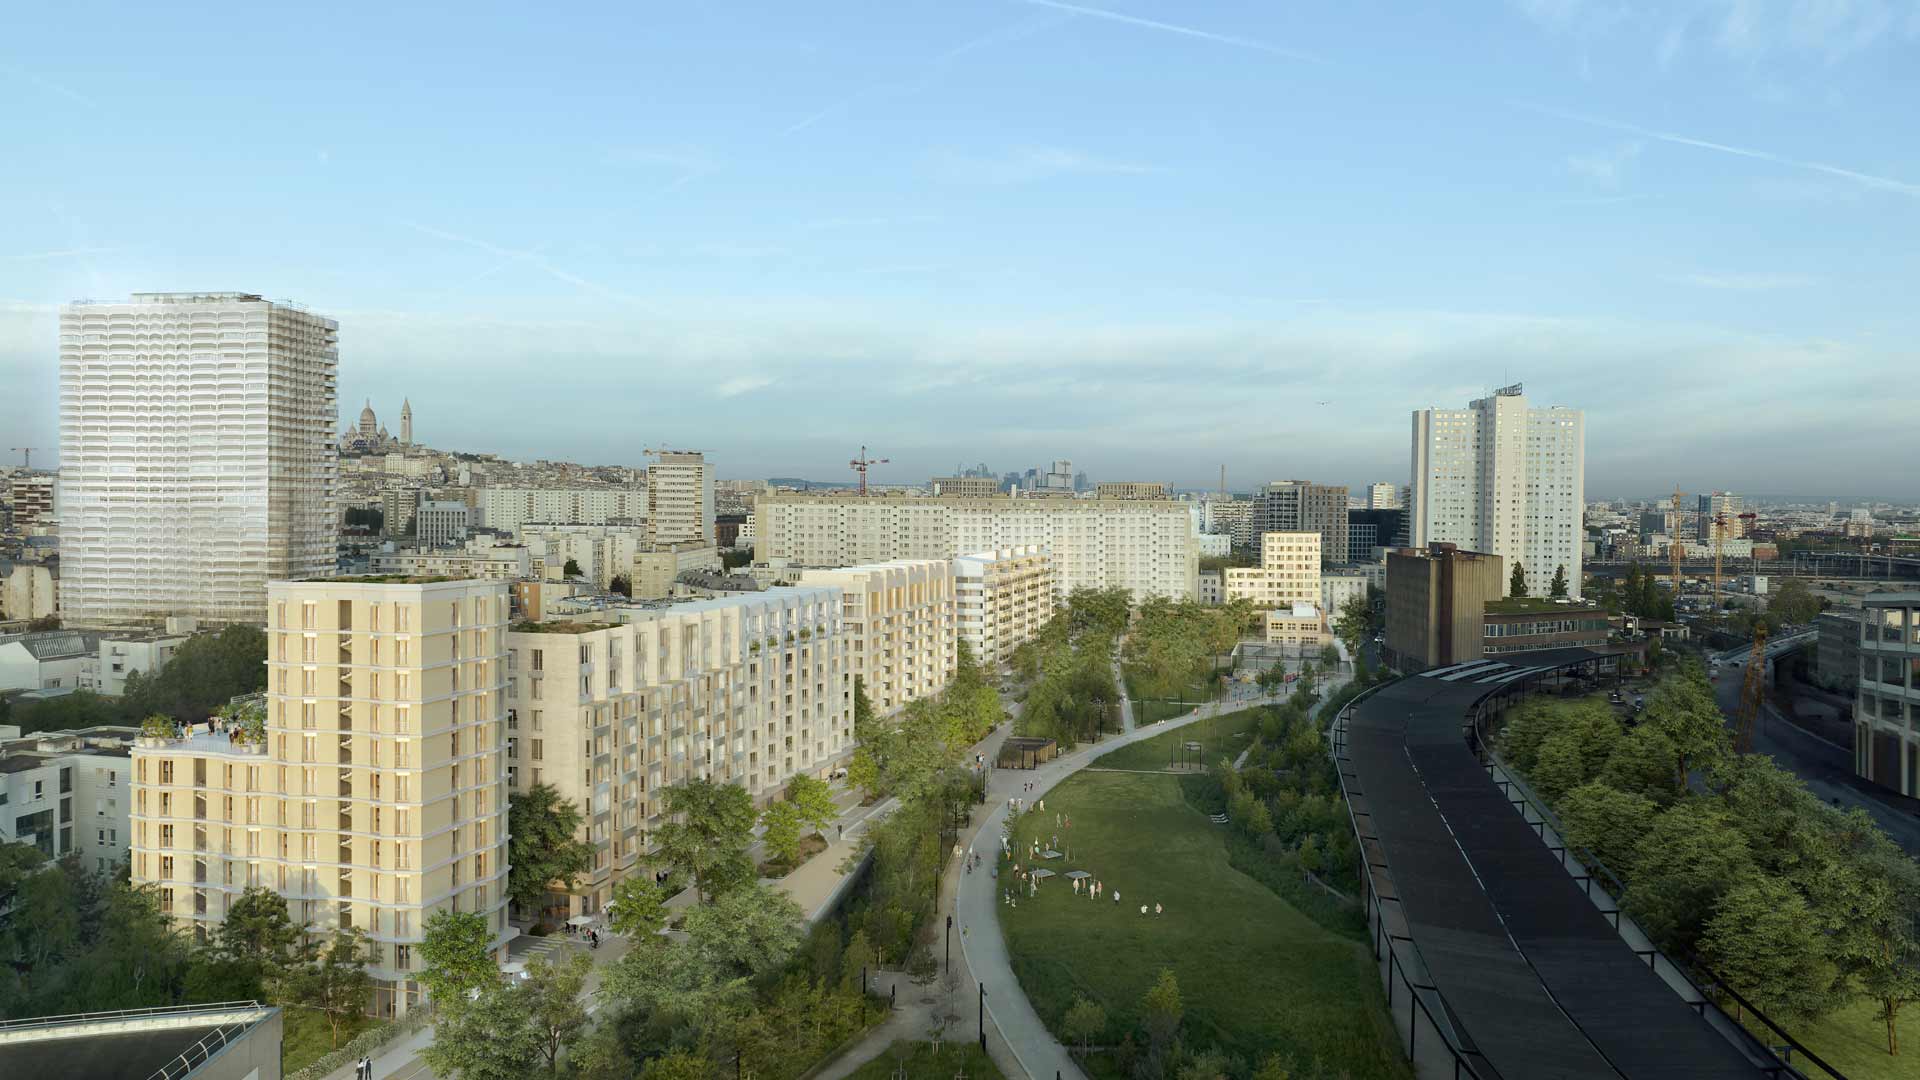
[0, 0, 1920, 496]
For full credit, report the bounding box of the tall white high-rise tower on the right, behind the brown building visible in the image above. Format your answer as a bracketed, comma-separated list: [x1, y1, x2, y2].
[1409, 382, 1586, 600]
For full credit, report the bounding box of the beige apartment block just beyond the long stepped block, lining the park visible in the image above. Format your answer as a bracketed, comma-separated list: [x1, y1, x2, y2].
[801, 559, 958, 715]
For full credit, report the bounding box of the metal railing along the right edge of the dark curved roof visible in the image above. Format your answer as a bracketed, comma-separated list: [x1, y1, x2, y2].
[1465, 673, 1847, 1080]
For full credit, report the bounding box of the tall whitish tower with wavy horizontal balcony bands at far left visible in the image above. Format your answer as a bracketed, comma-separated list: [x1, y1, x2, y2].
[60, 292, 338, 623]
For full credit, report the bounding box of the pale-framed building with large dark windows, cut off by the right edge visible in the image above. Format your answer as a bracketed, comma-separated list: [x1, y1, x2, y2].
[1853, 592, 1920, 798]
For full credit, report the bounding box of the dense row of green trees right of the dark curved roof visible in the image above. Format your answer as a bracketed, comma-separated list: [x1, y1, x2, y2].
[1500, 663, 1920, 1053]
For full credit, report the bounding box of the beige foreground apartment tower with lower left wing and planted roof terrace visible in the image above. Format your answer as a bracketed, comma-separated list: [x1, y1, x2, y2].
[131, 578, 513, 1017]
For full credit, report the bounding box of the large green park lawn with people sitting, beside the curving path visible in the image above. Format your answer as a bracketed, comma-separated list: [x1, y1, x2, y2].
[998, 773, 1411, 1080]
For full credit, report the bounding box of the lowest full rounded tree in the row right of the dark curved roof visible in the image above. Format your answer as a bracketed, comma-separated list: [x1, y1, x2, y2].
[1699, 874, 1837, 1020]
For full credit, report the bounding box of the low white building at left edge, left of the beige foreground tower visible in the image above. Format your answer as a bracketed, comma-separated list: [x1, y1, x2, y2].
[0, 726, 140, 872]
